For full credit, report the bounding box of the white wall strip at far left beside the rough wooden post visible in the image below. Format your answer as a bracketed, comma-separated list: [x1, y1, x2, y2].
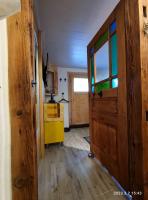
[0, 20, 11, 200]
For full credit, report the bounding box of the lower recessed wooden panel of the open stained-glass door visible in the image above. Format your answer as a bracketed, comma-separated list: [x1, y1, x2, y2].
[92, 120, 119, 177]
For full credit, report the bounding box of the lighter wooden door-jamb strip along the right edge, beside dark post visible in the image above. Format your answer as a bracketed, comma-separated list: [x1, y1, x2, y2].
[139, 0, 148, 199]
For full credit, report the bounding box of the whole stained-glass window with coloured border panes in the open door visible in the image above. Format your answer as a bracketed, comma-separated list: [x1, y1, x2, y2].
[90, 21, 119, 94]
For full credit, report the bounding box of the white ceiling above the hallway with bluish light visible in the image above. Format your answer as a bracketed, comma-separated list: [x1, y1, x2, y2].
[38, 0, 119, 68]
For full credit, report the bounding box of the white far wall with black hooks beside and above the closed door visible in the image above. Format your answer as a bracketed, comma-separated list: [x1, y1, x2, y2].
[46, 67, 87, 128]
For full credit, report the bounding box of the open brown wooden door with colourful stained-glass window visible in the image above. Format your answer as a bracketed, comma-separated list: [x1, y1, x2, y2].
[88, 1, 129, 193]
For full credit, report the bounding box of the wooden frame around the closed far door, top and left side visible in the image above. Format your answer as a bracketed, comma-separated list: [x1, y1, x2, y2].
[68, 72, 88, 126]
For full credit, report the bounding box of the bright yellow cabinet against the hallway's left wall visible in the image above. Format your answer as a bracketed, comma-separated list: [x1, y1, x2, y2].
[44, 104, 64, 144]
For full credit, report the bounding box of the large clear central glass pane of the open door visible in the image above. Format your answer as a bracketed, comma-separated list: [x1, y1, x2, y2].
[95, 41, 109, 83]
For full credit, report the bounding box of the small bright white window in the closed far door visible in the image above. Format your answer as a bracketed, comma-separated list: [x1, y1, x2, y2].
[74, 78, 89, 92]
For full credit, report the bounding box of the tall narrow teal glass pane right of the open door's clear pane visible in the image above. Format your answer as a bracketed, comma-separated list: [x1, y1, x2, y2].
[111, 34, 118, 76]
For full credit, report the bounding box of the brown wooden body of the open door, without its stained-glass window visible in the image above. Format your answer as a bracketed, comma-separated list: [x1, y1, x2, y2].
[88, 1, 128, 189]
